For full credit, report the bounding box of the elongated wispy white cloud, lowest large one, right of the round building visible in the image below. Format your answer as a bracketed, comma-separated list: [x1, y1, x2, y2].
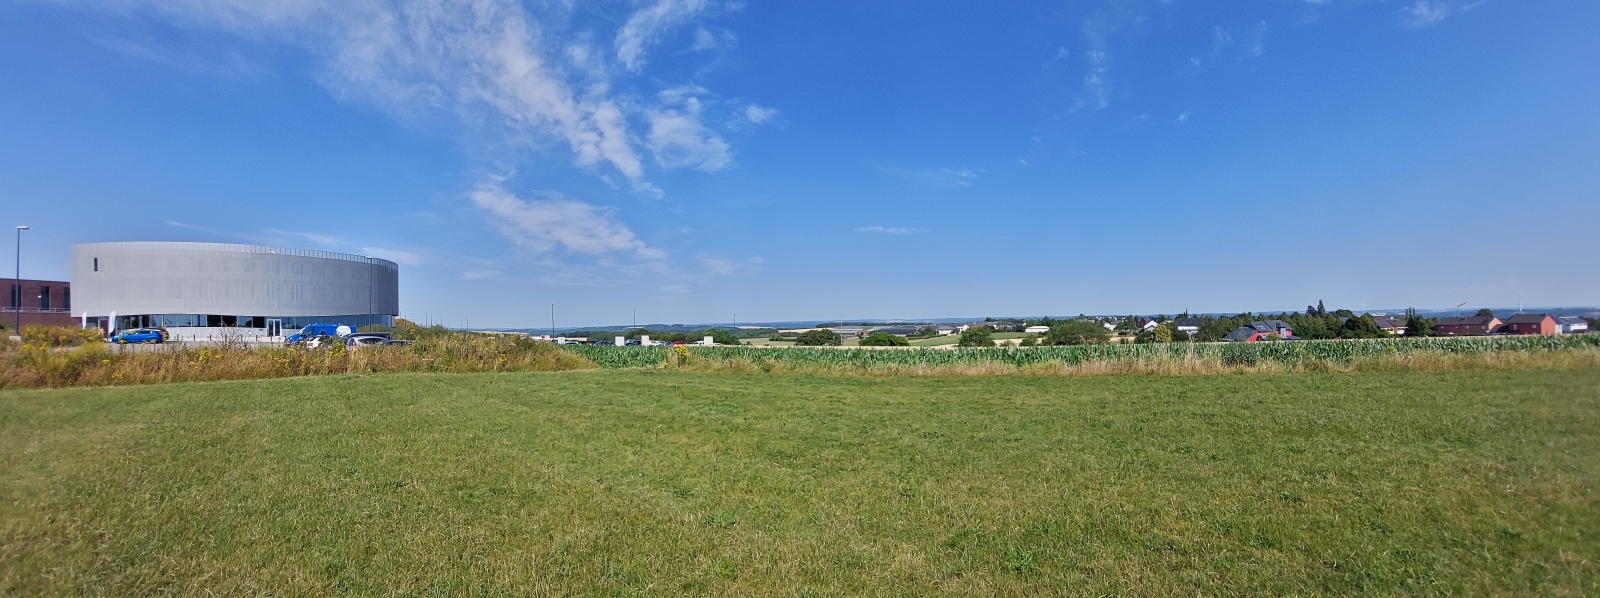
[472, 181, 667, 259]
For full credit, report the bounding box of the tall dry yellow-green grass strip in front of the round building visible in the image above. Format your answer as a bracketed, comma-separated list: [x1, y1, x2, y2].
[0, 331, 595, 389]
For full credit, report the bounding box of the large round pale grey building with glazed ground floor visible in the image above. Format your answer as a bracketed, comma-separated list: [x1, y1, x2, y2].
[72, 243, 400, 337]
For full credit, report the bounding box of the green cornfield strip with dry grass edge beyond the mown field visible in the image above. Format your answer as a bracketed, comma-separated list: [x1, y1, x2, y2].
[566, 334, 1600, 369]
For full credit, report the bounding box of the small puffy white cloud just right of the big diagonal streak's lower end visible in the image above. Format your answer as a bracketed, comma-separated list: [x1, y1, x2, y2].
[646, 88, 733, 173]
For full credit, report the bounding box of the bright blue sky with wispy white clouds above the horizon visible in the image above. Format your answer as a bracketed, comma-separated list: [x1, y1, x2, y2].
[0, 0, 1600, 326]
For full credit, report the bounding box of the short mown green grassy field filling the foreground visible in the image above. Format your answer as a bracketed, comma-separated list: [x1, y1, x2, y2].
[0, 368, 1600, 596]
